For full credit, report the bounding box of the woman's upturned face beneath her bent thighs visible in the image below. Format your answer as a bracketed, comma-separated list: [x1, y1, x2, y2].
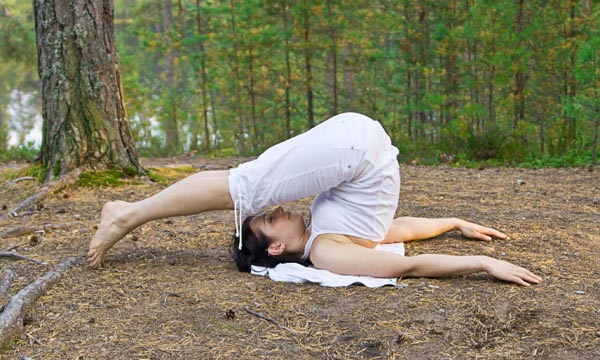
[250, 206, 306, 252]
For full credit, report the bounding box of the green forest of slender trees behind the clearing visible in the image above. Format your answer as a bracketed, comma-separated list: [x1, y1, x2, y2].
[0, 0, 600, 167]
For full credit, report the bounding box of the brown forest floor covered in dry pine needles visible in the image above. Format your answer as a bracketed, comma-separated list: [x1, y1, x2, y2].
[0, 158, 600, 359]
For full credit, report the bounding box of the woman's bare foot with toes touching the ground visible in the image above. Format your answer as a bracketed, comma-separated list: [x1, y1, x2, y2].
[88, 201, 135, 268]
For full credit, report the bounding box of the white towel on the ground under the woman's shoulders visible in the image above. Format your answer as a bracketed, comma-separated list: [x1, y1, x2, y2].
[251, 243, 404, 288]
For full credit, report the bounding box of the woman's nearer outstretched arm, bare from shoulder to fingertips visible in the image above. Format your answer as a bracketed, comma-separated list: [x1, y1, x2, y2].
[310, 238, 542, 286]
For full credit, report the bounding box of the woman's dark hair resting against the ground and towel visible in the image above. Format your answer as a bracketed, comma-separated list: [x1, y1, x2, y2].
[229, 216, 302, 272]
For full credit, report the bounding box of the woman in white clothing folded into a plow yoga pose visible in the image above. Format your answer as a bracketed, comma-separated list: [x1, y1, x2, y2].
[88, 113, 541, 286]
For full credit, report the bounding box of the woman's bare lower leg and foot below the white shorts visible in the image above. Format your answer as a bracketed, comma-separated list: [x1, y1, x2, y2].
[88, 170, 233, 267]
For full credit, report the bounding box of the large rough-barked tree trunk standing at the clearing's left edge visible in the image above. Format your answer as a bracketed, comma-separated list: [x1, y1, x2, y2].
[33, 0, 143, 181]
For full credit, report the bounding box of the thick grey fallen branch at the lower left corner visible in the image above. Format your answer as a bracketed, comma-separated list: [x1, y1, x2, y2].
[0, 258, 77, 346]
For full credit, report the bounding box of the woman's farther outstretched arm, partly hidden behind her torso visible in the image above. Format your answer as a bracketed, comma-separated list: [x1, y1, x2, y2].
[382, 216, 506, 244]
